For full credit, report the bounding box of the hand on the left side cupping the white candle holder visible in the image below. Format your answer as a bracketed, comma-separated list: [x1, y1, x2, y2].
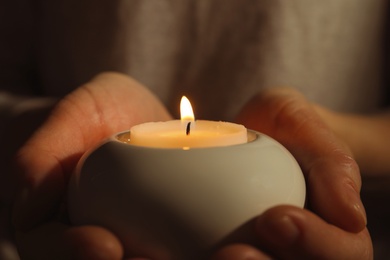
[14, 73, 170, 260]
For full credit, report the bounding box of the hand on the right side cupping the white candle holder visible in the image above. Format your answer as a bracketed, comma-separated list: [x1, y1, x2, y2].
[214, 88, 373, 260]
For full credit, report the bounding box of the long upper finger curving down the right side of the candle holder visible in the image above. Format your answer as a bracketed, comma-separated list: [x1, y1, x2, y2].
[238, 88, 366, 232]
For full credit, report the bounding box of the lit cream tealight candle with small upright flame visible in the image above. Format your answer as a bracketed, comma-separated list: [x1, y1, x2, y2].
[130, 96, 247, 148]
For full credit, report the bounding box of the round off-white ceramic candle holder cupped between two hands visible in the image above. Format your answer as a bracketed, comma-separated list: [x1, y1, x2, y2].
[68, 130, 305, 259]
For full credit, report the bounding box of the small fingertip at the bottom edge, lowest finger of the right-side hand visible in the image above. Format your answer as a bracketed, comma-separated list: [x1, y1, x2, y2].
[211, 244, 271, 260]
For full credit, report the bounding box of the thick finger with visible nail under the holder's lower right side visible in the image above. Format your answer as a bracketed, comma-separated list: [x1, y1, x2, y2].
[256, 206, 373, 259]
